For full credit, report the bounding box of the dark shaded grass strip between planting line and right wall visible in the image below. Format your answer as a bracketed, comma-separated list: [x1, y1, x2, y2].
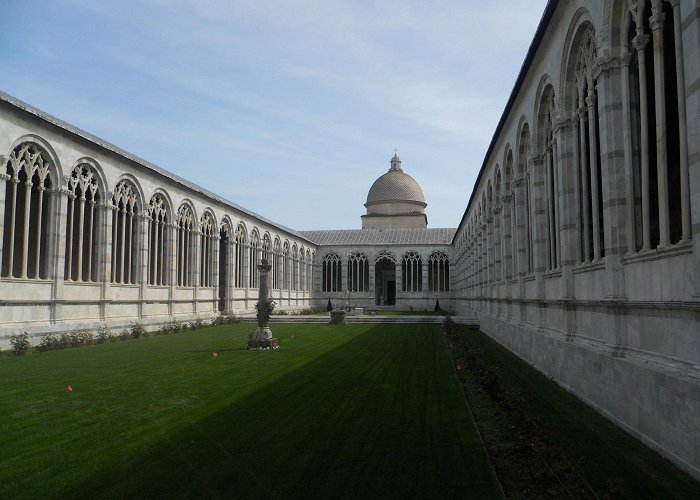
[447, 327, 700, 499]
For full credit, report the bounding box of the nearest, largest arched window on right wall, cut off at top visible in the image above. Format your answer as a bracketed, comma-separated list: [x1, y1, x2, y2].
[623, 0, 692, 251]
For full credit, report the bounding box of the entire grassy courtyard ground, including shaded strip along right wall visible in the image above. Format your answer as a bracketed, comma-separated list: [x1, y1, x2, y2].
[0, 324, 698, 498]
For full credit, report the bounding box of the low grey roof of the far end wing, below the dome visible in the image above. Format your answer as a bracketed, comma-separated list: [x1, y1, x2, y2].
[300, 228, 456, 246]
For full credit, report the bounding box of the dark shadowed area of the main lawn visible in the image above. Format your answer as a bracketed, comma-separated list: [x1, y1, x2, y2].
[61, 326, 500, 498]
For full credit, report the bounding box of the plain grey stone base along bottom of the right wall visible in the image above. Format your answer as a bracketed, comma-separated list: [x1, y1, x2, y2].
[470, 311, 700, 479]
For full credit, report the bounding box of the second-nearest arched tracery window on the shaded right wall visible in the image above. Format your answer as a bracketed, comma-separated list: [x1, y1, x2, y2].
[574, 30, 605, 262]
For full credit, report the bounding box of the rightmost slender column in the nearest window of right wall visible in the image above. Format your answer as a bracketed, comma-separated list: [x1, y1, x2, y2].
[668, 0, 692, 242]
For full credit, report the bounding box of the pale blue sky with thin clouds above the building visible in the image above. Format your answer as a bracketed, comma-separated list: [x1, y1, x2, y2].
[0, 0, 546, 230]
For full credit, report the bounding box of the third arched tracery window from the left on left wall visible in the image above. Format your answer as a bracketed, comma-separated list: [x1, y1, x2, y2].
[111, 179, 139, 285]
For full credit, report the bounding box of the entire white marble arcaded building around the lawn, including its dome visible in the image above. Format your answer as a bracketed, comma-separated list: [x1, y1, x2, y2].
[0, 0, 700, 478]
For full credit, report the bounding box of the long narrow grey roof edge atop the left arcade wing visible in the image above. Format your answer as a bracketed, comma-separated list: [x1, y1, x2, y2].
[0, 91, 312, 246]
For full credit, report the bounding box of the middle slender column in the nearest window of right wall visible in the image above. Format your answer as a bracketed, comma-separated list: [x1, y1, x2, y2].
[649, 0, 671, 247]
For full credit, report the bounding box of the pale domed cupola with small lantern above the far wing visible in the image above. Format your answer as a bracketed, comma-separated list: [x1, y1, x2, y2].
[362, 155, 428, 229]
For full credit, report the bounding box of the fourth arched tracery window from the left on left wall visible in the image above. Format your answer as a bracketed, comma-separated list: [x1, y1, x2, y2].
[148, 194, 170, 286]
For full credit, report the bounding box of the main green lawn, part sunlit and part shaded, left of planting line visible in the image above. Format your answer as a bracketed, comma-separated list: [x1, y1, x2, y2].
[0, 324, 501, 498]
